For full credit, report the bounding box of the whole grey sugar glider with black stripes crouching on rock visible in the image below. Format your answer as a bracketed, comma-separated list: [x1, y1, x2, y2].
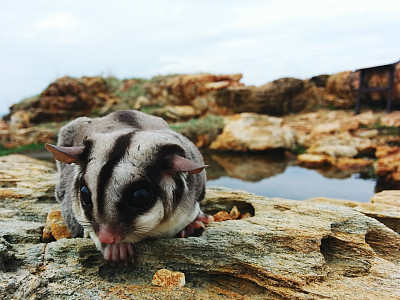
[46, 110, 212, 262]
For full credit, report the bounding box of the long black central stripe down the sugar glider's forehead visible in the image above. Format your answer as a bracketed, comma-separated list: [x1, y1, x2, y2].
[97, 132, 134, 214]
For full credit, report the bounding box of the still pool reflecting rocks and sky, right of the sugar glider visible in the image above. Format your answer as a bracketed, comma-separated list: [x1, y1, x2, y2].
[203, 152, 376, 202]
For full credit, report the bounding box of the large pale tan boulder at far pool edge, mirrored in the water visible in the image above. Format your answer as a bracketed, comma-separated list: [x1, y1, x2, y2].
[210, 113, 295, 152]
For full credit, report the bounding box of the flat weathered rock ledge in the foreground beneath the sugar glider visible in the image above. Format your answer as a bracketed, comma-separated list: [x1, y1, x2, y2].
[0, 155, 400, 299]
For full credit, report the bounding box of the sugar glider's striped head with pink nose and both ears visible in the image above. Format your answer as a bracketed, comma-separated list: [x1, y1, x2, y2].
[46, 130, 206, 244]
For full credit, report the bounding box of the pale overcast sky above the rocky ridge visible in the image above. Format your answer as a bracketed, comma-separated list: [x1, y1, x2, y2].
[0, 0, 400, 115]
